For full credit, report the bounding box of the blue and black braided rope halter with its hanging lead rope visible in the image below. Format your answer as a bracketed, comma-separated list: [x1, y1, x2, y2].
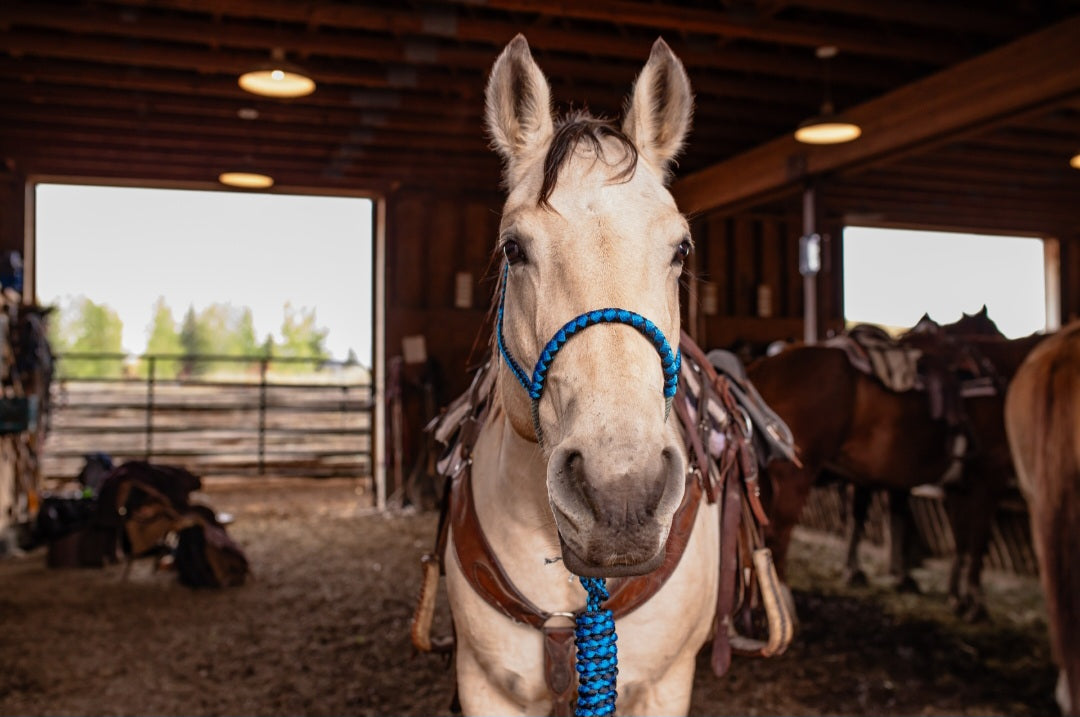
[495, 265, 683, 717]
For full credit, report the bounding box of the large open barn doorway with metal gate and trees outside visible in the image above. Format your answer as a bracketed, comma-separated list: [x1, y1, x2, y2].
[27, 182, 381, 488]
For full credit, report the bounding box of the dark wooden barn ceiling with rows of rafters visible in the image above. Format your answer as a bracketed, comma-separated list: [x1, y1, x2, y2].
[0, 0, 1080, 232]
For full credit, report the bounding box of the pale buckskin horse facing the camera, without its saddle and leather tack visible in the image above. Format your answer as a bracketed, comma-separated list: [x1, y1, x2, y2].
[445, 36, 719, 715]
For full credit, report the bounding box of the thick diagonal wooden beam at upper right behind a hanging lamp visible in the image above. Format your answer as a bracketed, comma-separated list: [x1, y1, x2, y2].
[674, 17, 1080, 212]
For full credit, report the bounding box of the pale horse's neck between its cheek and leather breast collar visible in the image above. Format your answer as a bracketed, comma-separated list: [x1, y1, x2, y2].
[472, 411, 584, 611]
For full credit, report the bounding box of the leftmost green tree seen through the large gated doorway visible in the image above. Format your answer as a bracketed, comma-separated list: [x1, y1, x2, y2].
[50, 296, 124, 378]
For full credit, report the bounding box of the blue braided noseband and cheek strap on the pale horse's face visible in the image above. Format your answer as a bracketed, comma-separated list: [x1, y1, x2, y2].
[495, 265, 683, 444]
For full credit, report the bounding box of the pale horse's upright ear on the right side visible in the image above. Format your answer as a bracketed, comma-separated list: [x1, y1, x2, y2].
[622, 38, 693, 179]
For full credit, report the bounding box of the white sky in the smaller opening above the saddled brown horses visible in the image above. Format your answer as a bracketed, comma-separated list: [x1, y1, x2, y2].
[843, 227, 1047, 338]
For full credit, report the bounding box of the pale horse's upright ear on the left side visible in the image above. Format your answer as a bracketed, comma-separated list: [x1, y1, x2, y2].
[485, 35, 554, 174]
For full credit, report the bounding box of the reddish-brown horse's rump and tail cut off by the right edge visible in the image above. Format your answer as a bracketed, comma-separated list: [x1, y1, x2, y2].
[1005, 322, 1080, 715]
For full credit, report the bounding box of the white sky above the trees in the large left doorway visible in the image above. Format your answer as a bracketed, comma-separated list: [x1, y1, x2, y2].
[36, 185, 372, 366]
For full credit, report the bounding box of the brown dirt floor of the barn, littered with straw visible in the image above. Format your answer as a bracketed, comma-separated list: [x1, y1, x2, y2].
[0, 481, 1056, 715]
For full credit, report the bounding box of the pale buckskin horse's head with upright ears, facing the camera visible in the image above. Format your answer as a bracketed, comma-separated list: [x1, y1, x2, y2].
[486, 36, 692, 576]
